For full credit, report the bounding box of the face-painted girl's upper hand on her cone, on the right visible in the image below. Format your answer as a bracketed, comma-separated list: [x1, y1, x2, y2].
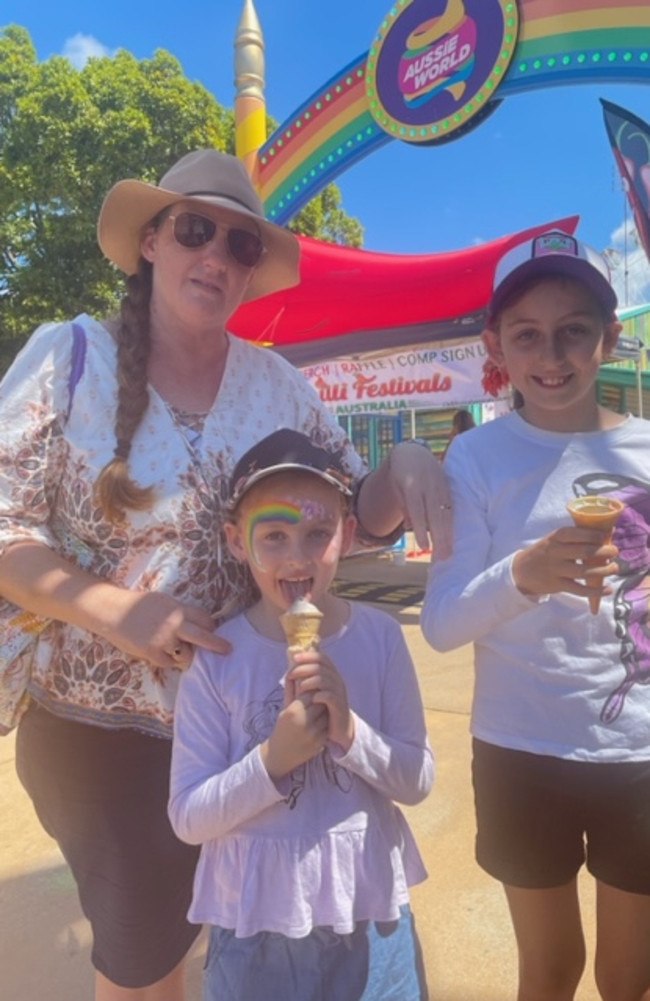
[286, 651, 355, 752]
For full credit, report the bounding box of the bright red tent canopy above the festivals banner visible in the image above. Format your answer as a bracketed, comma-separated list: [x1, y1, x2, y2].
[228, 215, 579, 365]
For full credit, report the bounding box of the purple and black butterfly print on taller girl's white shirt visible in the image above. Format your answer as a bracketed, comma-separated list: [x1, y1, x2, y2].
[574, 472, 650, 723]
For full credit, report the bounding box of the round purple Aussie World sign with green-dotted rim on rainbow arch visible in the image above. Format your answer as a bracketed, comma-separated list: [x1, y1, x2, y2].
[366, 0, 519, 143]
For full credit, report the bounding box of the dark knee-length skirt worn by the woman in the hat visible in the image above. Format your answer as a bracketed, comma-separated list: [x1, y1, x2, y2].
[16, 704, 200, 988]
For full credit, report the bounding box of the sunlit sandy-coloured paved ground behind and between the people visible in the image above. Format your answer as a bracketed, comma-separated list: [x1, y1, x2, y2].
[0, 554, 598, 1001]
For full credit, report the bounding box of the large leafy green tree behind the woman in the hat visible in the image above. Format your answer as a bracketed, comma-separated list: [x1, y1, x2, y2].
[0, 25, 362, 371]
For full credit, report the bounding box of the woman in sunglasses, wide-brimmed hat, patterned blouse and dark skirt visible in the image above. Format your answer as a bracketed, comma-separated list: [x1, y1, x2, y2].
[0, 150, 449, 1001]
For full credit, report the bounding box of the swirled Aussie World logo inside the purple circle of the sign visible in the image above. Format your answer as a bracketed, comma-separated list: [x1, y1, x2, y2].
[398, 0, 477, 106]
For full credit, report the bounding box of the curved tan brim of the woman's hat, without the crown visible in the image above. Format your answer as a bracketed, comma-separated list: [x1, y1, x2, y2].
[97, 180, 300, 301]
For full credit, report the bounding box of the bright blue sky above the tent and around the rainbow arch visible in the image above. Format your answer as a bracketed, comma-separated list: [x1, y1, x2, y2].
[5, 0, 650, 305]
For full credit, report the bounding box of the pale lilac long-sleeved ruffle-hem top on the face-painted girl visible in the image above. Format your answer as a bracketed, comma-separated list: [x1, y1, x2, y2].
[169, 605, 434, 938]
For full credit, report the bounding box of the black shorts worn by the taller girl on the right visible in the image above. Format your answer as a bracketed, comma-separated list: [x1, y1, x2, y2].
[472, 740, 650, 894]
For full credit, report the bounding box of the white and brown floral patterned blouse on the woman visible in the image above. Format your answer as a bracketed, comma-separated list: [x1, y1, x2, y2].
[0, 314, 366, 737]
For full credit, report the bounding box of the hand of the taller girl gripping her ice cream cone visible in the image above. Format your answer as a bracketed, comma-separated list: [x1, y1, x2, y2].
[513, 528, 618, 598]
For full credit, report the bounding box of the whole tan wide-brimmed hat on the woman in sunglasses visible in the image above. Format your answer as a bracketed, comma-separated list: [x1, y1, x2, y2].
[97, 149, 300, 300]
